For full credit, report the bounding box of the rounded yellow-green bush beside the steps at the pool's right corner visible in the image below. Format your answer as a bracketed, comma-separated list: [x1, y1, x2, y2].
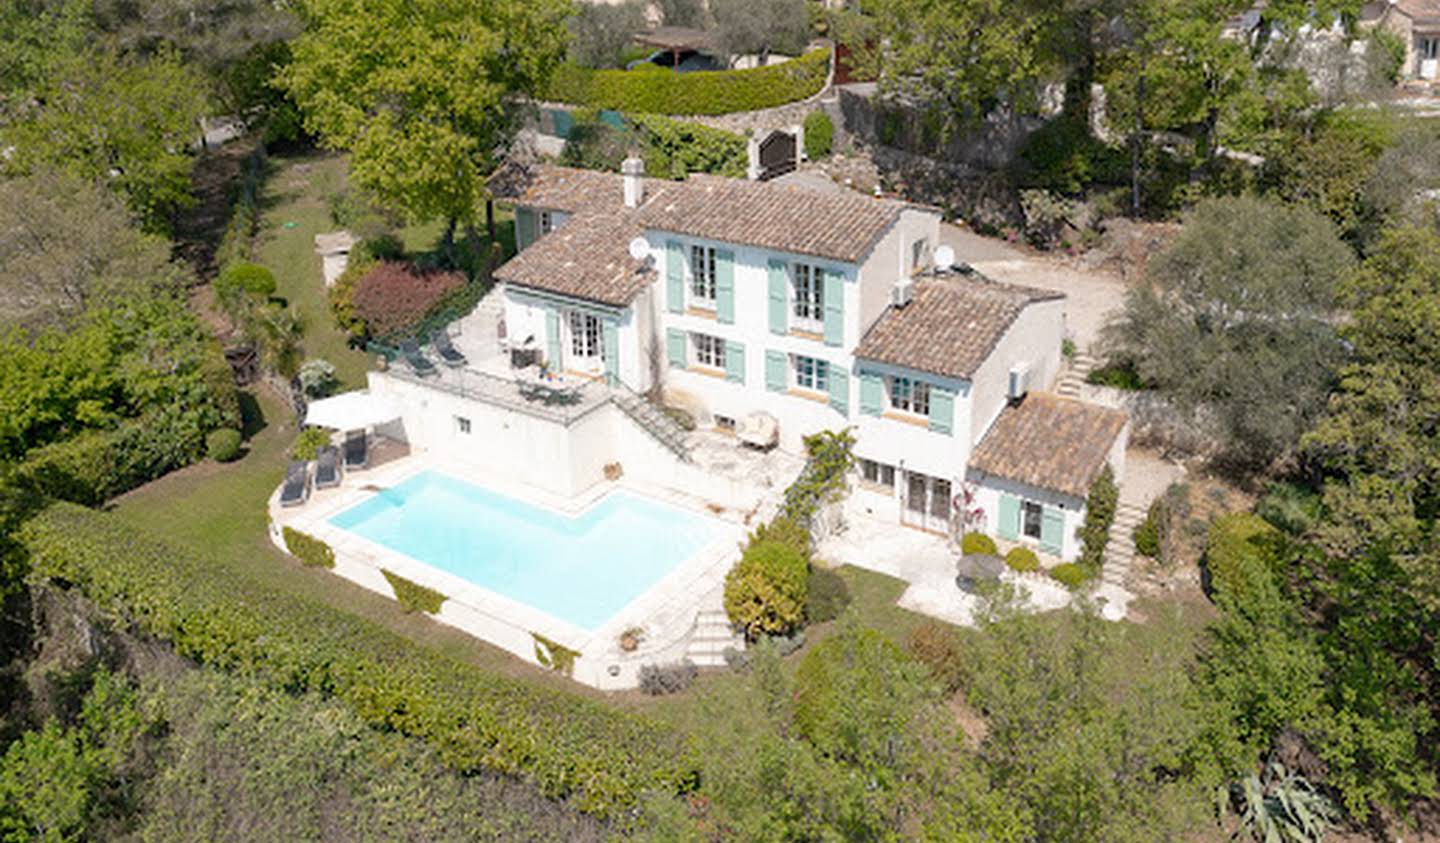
[724, 542, 809, 641]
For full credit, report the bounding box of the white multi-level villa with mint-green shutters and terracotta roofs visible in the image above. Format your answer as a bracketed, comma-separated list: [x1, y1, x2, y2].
[478, 160, 1128, 559]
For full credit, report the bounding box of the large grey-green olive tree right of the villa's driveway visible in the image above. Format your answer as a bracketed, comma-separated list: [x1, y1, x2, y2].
[1104, 199, 1354, 467]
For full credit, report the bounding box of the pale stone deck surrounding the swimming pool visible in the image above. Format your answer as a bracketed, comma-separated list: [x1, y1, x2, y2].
[269, 452, 746, 690]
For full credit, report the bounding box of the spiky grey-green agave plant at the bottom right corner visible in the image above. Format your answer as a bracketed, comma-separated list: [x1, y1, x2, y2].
[1230, 761, 1339, 843]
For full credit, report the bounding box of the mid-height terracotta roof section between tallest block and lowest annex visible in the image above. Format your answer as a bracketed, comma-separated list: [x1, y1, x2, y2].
[855, 274, 1064, 378]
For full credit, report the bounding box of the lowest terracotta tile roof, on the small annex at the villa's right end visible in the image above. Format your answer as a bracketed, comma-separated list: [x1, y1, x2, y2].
[971, 392, 1129, 497]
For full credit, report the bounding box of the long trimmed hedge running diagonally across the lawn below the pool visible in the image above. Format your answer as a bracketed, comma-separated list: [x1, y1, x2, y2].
[20, 503, 698, 817]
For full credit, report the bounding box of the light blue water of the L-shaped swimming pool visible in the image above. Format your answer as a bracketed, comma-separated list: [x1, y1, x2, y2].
[330, 471, 720, 630]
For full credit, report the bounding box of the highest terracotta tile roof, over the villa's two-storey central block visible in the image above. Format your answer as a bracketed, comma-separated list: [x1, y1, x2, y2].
[636, 176, 906, 264]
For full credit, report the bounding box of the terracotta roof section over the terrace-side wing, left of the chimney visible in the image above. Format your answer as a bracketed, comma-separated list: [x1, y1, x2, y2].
[495, 213, 655, 307]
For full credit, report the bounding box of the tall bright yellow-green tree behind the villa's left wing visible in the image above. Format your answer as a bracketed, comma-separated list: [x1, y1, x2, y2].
[282, 0, 570, 257]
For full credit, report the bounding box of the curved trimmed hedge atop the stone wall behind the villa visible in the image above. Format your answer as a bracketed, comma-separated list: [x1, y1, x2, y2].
[543, 49, 829, 115]
